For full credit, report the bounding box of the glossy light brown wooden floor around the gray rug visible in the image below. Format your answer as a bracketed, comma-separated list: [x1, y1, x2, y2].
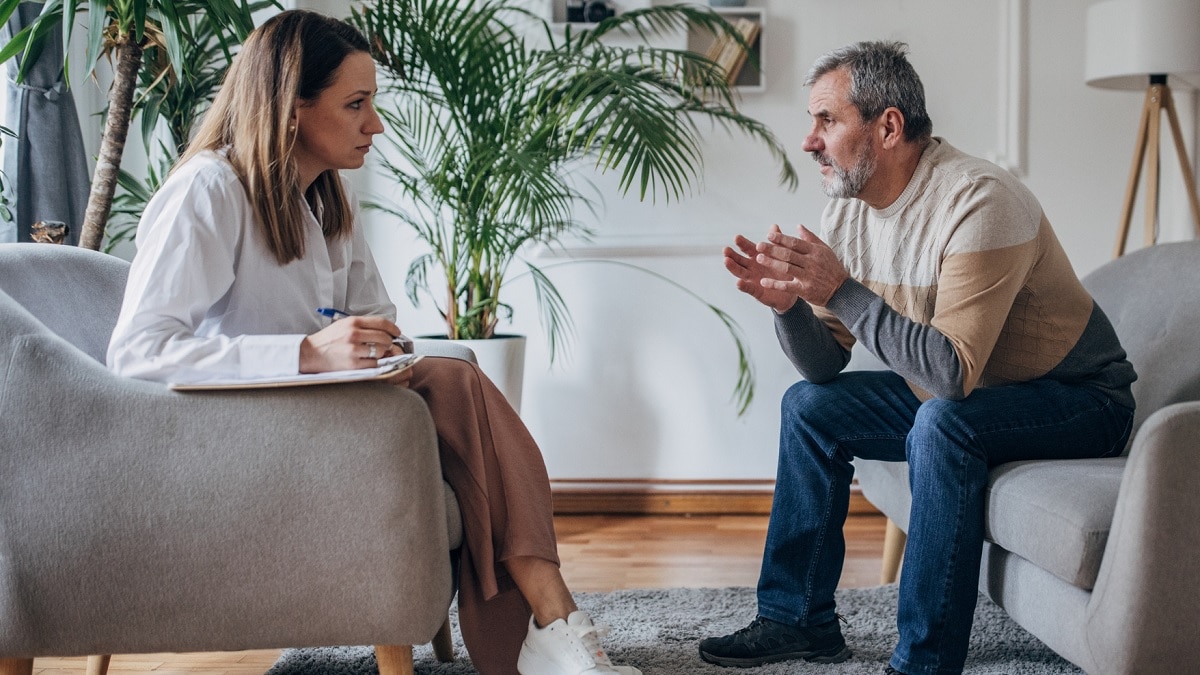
[34, 515, 884, 675]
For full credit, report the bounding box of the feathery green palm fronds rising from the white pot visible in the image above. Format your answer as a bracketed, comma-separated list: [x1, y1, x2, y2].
[350, 0, 796, 410]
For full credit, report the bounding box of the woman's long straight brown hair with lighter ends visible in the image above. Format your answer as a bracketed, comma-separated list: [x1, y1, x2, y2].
[176, 10, 370, 264]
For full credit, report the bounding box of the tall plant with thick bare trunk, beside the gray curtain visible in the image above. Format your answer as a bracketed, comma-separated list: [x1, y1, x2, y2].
[0, 0, 261, 250]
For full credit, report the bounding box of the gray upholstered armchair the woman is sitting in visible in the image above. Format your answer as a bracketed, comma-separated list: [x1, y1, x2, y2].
[0, 244, 462, 675]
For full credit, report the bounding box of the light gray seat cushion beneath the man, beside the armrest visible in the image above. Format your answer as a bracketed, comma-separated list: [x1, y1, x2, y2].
[984, 456, 1126, 590]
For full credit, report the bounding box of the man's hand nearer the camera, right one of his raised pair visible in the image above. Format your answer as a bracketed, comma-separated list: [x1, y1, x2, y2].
[755, 225, 850, 307]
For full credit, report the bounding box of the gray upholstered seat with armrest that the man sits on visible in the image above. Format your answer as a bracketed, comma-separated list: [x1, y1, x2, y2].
[856, 241, 1200, 675]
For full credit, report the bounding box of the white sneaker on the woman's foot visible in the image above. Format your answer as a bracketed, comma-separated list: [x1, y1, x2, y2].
[517, 611, 642, 675]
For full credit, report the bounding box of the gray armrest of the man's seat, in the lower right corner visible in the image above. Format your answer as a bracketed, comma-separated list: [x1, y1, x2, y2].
[1087, 401, 1200, 673]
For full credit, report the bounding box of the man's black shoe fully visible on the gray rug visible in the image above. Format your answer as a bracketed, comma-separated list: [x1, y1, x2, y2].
[700, 616, 850, 668]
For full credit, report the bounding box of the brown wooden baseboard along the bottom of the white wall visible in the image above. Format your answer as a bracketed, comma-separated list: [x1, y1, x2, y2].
[551, 479, 881, 515]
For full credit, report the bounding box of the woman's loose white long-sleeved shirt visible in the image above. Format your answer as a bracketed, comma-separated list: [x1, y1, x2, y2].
[108, 153, 396, 382]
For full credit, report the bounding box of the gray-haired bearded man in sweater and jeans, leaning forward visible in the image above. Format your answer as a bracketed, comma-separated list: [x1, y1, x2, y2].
[700, 42, 1135, 675]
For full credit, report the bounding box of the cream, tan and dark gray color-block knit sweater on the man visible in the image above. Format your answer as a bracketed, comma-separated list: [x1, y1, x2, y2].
[776, 138, 1136, 398]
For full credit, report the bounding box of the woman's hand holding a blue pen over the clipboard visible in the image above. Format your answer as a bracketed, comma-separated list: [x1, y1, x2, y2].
[300, 316, 400, 372]
